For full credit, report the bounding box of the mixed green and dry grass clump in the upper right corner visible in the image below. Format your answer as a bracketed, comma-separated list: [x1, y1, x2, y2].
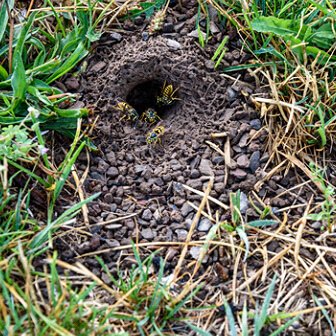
[200, 0, 336, 162]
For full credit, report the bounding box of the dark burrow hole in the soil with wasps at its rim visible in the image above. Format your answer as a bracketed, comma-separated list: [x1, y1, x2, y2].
[126, 79, 179, 119]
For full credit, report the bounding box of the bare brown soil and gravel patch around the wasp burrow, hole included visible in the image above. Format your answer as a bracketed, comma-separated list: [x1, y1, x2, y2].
[51, 2, 334, 334]
